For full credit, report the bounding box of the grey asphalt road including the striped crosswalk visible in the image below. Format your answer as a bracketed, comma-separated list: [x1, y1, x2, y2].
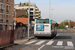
[7, 33, 75, 50]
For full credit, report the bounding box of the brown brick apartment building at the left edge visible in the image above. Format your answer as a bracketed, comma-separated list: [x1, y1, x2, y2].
[0, 0, 14, 30]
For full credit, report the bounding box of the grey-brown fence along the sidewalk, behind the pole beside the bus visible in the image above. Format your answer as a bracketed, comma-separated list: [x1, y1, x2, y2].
[15, 29, 34, 39]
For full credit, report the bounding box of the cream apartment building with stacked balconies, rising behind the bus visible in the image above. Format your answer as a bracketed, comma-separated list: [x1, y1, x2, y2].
[14, 3, 41, 20]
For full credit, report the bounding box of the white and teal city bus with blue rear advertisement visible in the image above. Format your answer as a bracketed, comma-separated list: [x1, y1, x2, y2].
[34, 19, 57, 37]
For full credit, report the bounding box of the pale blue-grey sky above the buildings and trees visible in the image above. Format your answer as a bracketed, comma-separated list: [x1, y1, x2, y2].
[15, 0, 75, 22]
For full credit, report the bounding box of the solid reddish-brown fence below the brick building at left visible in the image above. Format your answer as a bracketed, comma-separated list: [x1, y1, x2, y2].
[0, 30, 15, 47]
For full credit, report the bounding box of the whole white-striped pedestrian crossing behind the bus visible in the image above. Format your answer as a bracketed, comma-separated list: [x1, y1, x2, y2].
[25, 40, 74, 47]
